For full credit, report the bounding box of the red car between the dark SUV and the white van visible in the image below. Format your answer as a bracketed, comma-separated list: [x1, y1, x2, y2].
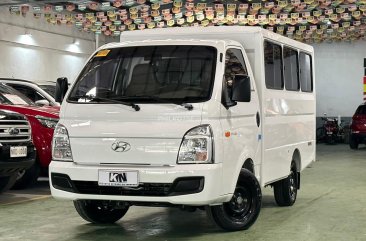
[0, 83, 60, 189]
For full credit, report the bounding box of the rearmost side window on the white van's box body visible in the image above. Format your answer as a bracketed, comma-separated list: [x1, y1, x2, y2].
[299, 52, 313, 92]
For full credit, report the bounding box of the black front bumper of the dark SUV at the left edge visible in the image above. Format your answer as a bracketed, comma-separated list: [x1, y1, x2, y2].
[0, 142, 36, 176]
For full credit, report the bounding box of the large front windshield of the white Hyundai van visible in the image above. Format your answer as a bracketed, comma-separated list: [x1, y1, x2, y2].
[68, 45, 217, 103]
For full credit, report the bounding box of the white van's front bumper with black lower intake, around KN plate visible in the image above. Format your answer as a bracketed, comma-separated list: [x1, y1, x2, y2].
[49, 161, 232, 206]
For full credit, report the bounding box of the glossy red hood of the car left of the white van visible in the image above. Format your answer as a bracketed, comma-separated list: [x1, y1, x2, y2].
[0, 104, 60, 118]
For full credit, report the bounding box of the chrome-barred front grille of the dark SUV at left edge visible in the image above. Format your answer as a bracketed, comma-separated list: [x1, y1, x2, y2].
[0, 120, 31, 143]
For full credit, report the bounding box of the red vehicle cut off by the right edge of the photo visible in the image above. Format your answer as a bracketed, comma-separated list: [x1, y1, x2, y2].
[349, 103, 366, 149]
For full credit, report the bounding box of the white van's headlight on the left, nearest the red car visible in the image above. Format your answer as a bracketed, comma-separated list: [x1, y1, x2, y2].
[52, 124, 73, 161]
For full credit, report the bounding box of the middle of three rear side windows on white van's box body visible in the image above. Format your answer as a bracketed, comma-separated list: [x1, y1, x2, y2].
[283, 47, 300, 91]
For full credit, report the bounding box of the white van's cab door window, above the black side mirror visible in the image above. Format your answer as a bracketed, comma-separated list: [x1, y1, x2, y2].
[225, 49, 248, 81]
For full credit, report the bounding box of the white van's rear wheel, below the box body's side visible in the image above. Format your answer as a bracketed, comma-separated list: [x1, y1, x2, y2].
[273, 162, 299, 207]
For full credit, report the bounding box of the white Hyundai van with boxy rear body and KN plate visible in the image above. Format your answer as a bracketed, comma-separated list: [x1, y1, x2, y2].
[49, 26, 316, 231]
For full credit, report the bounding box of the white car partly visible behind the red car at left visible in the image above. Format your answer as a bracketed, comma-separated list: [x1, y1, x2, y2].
[0, 78, 60, 106]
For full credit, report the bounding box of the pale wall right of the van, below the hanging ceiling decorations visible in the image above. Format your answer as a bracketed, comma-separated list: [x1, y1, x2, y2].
[314, 40, 366, 117]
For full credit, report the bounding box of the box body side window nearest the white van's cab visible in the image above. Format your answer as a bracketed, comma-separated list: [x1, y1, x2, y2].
[264, 41, 283, 90]
